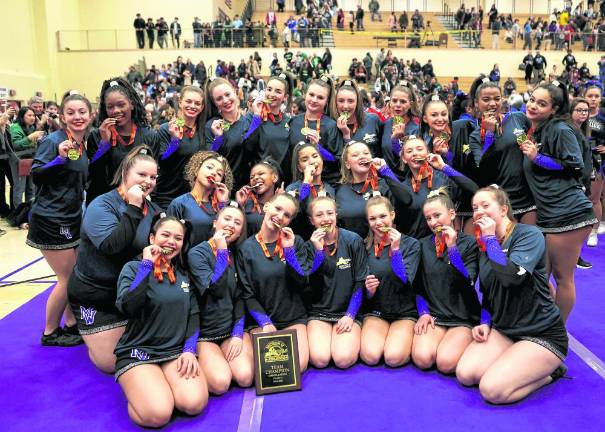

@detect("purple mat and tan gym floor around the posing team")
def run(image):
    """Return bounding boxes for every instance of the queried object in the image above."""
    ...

[0,221,605,432]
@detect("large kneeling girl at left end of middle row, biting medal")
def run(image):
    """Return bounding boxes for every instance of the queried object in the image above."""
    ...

[67,146,159,373]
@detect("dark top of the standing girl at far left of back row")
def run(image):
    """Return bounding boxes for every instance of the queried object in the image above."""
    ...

[31,130,88,224]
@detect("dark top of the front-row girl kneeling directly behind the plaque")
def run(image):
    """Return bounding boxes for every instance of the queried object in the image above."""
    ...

[235,236,310,328]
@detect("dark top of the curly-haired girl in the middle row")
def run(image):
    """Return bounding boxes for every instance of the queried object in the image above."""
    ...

[166,192,216,246]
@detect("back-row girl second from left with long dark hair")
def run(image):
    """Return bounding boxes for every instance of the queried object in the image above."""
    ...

[86,78,160,203]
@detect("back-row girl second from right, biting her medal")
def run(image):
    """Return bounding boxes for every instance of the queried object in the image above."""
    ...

[469,79,536,225]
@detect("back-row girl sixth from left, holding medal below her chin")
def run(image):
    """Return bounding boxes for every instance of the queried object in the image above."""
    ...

[289,75,342,186]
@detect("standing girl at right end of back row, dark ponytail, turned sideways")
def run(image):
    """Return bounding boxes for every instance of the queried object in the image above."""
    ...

[521,81,598,321]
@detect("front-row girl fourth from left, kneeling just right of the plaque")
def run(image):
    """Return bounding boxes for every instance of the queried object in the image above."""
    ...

[307,197,368,368]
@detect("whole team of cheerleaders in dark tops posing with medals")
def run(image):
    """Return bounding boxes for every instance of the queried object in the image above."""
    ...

[27,71,601,426]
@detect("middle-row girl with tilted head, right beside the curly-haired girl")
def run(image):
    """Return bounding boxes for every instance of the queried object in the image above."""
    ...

[235,159,284,233]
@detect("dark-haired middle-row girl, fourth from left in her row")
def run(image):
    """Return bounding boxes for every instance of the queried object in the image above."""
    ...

[286,141,336,239]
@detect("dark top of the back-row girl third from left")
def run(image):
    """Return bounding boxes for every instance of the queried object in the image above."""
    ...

[151,123,205,209]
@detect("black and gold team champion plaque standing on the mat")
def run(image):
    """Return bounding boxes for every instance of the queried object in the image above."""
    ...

[252,330,301,395]
